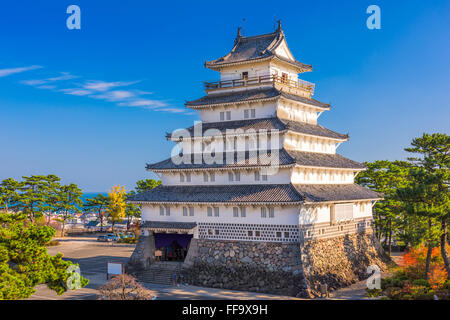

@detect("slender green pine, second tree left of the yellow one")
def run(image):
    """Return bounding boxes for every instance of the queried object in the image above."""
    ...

[56,183,83,237]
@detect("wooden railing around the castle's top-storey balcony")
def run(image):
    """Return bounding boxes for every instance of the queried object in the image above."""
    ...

[204,75,315,95]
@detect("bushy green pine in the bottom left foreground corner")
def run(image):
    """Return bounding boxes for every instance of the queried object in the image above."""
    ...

[0,211,89,300]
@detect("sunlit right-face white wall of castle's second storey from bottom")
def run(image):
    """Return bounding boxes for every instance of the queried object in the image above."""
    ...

[291,166,355,184]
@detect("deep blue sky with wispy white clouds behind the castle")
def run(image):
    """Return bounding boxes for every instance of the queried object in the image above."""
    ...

[0,0,450,192]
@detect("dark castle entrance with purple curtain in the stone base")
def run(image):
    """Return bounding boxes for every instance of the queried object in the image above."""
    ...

[155,233,192,262]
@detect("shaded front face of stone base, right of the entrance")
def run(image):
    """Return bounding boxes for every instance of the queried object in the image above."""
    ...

[183,239,306,296]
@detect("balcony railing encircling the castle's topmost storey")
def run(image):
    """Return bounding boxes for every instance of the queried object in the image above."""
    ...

[204,75,315,97]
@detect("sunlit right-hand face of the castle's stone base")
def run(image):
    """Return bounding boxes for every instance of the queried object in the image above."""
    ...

[301,233,390,295]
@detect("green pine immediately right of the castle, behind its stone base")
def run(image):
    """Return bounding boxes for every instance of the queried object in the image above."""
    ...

[355,160,410,255]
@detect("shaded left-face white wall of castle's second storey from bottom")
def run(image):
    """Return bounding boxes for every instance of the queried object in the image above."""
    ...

[161,168,291,186]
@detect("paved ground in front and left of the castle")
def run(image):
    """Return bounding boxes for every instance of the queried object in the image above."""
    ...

[30,235,386,300]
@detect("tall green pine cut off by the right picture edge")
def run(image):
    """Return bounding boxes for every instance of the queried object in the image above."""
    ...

[405,133,450,279]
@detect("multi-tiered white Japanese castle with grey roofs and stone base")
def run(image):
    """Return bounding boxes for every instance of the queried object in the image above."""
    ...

[130,22,383,296]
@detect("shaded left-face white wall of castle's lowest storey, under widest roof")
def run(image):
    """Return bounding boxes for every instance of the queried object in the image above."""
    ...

[141,204,298,225]
